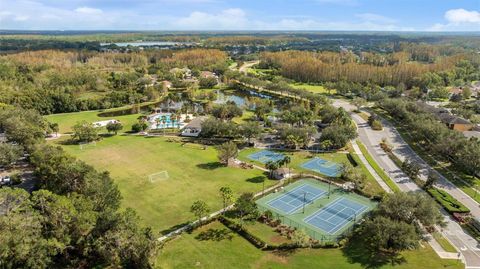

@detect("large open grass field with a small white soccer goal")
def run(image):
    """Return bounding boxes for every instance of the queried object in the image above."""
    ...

[53,135,275,231]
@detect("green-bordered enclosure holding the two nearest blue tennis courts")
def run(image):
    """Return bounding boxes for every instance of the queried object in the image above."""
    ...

[257,179,376,242]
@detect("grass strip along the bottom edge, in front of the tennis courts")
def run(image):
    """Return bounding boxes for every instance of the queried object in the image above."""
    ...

[156,219,464,269]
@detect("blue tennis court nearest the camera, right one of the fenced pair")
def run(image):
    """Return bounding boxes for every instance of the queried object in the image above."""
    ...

[304,198,368,234]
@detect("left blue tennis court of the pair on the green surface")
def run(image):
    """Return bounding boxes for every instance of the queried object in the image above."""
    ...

[267,184,327,214]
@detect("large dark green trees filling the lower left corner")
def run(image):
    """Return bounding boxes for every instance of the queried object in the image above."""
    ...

[0,106,156,268]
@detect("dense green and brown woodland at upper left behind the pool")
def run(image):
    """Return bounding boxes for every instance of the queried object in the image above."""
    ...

[0,49,228,114]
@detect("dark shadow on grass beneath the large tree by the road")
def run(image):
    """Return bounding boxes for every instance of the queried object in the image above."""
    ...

[342,235,406,269]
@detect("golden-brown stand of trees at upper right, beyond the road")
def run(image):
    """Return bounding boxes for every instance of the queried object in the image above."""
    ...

[260,45,480,88]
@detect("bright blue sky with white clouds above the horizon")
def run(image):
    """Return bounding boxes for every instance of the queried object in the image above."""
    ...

[0,0,480,31]
